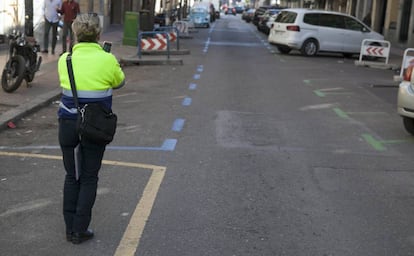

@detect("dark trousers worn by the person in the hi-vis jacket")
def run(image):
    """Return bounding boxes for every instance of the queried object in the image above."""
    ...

[59,119,105,233]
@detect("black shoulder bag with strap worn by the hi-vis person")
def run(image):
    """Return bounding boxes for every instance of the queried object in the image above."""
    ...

[66,54,118,145]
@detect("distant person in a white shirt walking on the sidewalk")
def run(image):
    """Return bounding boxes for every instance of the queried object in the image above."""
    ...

[42,0,62,54]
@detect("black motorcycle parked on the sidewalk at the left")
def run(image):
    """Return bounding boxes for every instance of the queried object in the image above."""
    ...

[1,30,42,93]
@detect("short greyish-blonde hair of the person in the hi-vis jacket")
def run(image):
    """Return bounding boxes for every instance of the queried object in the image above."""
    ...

[72,13,101,42]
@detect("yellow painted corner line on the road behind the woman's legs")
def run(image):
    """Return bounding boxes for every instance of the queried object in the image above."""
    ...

[0,151,167,256]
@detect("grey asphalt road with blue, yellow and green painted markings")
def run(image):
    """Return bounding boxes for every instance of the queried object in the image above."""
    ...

[0,15,414,256]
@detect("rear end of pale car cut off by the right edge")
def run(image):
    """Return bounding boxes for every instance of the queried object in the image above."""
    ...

[397,65,414,135]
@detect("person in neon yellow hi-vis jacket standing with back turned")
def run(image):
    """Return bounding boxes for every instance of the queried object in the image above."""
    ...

[58,13,125,244]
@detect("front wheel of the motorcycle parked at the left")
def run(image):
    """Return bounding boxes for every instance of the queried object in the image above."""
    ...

[1,55,26,93]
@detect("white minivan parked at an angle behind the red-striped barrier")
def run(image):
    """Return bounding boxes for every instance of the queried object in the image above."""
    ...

[268,9,384,57]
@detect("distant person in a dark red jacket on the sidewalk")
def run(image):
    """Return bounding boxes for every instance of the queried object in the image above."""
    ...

[59,0,80,55]
